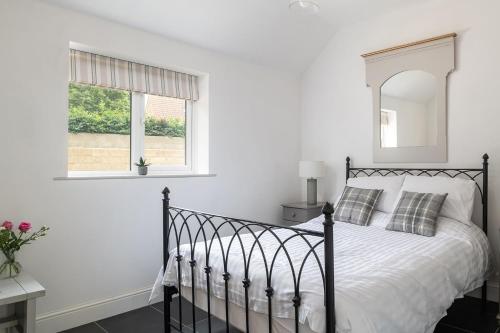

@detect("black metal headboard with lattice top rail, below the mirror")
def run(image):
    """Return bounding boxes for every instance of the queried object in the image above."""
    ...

[346,154,489,305]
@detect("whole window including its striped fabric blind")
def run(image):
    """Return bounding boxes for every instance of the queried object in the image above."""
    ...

[68,50,201,176]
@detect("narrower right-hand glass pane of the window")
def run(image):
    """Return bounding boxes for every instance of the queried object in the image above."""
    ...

[144,95,186,166]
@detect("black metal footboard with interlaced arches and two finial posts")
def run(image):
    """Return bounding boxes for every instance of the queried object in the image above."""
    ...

[163,188,335,333]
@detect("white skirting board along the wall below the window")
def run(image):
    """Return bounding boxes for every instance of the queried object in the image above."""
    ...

[36,287,156,333]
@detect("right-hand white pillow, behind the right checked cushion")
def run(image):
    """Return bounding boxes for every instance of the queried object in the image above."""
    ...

[398,176,476,225]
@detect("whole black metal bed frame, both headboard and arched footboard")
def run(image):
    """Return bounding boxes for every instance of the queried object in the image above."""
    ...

[162,154,488,333]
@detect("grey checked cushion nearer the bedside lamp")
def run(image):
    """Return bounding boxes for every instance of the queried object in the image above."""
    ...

[333,186,383,225]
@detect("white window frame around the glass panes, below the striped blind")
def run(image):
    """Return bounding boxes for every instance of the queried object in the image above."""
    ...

[66,87,196,177]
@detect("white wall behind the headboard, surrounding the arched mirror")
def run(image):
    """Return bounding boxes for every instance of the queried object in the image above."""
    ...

[301,0,500,296]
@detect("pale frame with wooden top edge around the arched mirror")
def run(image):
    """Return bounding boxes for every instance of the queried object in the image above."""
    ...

[362,33,456,163]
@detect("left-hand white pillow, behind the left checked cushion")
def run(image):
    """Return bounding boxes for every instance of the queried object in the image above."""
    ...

[347,176,405,213]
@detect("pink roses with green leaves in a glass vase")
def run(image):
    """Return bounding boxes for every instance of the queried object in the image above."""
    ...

[0,221,49,278]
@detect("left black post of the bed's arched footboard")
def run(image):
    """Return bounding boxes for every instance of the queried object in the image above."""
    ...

[162,187,177,333]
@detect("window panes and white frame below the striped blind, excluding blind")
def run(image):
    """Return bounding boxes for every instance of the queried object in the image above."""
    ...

[68,83,191,172]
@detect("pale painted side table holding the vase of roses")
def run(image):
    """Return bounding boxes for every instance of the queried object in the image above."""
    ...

[0,273,45,333]
